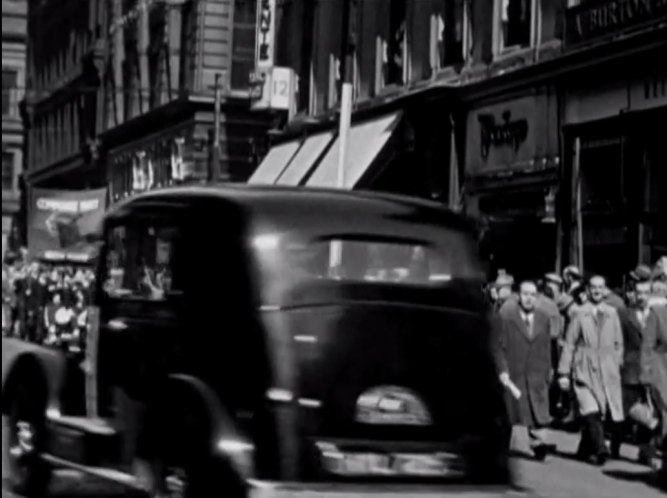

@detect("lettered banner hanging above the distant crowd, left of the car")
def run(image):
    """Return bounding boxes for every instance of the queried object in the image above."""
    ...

[28,189,107,262]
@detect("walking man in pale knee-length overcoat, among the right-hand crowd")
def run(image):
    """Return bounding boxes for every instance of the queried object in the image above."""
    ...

[558,276,624,465]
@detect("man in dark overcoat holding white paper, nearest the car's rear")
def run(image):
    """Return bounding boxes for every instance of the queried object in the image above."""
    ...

[496,281,551,461]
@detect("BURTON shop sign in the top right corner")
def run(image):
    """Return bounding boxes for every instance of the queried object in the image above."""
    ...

[565,0,667,45]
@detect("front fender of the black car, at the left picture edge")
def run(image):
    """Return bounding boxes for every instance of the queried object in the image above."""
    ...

[2,338,66,415]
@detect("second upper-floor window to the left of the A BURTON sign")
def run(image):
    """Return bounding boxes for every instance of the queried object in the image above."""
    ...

[432,0,466,68]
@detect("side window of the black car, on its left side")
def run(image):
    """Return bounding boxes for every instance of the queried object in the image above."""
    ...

[103,223,180,301]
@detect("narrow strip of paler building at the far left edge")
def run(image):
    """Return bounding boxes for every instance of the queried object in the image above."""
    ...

[2,0,27,257]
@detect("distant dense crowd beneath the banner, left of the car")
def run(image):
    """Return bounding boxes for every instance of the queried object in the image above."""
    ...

[2,247,95,352]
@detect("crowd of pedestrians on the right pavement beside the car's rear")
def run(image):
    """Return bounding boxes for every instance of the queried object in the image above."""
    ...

[488,257,667,486]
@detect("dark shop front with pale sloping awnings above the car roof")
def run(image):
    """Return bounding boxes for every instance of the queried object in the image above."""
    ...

[248,94,453,202]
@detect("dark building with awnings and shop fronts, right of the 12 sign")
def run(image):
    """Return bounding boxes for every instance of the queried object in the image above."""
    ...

[250,0,667,282]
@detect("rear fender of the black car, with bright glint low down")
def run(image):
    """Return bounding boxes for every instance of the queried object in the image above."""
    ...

[148,374,254,478]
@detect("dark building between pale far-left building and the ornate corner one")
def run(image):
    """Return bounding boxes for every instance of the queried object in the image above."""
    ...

[24,0,106,191]
